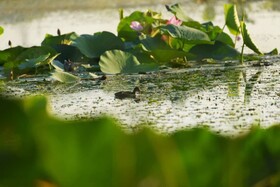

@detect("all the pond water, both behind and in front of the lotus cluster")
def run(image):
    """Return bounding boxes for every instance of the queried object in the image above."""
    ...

[0,0,280,135]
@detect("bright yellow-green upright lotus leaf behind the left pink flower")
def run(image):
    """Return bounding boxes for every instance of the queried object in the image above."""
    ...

[117,11,155,41]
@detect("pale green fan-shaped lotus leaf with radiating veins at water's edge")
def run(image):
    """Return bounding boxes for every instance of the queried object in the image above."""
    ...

[99,50,140,74]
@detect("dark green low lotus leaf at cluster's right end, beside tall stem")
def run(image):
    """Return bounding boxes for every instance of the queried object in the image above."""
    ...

[189,41,239,60]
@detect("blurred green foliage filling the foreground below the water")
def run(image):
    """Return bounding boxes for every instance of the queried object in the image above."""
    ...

[0,97,280,187]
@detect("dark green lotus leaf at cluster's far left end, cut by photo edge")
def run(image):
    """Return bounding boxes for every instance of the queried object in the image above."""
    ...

[0,46,27,65]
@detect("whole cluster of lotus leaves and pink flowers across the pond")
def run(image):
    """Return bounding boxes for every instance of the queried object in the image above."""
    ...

[0,4,277,82]
